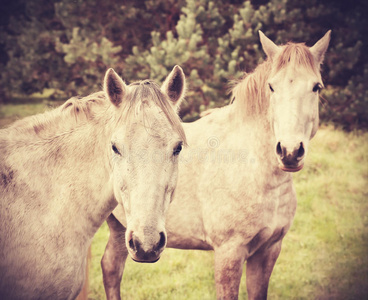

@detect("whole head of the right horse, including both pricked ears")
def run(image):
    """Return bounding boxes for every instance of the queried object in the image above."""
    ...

[261,32,330,172]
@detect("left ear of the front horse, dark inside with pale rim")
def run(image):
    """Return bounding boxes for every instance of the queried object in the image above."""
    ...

[104,68,126,106]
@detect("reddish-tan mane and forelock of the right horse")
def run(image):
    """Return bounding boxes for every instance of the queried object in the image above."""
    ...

[231,43,320,117]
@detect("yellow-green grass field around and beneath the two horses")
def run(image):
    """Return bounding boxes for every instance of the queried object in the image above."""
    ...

[0,104,368,300]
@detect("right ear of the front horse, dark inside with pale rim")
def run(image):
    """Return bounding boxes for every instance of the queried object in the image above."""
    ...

[161,65,185,108]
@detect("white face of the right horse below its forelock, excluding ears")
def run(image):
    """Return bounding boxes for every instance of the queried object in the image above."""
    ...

[269,69,322,172]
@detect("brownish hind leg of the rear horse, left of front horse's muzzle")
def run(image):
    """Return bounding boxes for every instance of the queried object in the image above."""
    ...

[101,214,128,300]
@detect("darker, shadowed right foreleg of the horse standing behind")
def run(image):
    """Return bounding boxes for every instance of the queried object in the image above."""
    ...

[246,240,282,300]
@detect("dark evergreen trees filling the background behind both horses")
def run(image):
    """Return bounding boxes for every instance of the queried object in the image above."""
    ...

[0,0,368,129]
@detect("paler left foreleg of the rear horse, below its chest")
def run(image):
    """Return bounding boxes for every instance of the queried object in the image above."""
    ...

[215,245,245,300]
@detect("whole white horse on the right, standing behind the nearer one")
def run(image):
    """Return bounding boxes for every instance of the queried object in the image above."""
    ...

[102,31,330,299]
